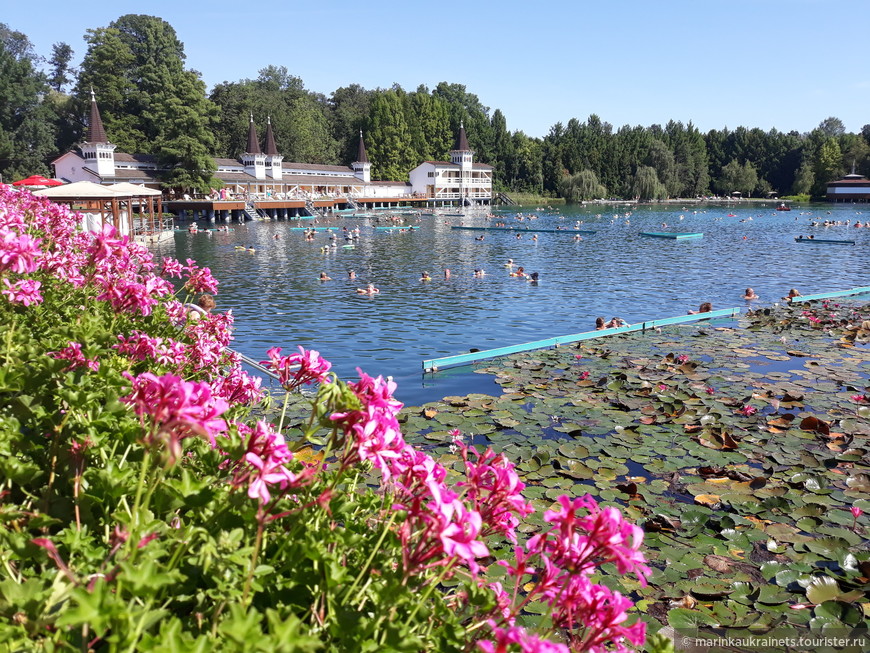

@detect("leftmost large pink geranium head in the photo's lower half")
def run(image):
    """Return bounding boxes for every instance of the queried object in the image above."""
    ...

[121,372,229,464]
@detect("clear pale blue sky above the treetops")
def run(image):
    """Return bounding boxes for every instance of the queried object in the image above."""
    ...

[8,0,870,136]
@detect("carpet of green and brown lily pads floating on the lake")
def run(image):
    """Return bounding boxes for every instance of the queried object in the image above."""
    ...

[396,302,870,630]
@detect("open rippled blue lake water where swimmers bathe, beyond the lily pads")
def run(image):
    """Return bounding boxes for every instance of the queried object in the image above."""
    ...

[156,202,870,405]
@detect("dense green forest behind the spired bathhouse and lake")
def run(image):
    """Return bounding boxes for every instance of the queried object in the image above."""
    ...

[0,14,870,196]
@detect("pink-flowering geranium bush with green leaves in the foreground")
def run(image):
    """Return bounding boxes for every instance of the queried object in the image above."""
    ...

[0,187,649,652]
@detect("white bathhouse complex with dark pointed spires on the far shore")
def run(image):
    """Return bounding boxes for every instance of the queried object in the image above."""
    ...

[52,91,492,208]
